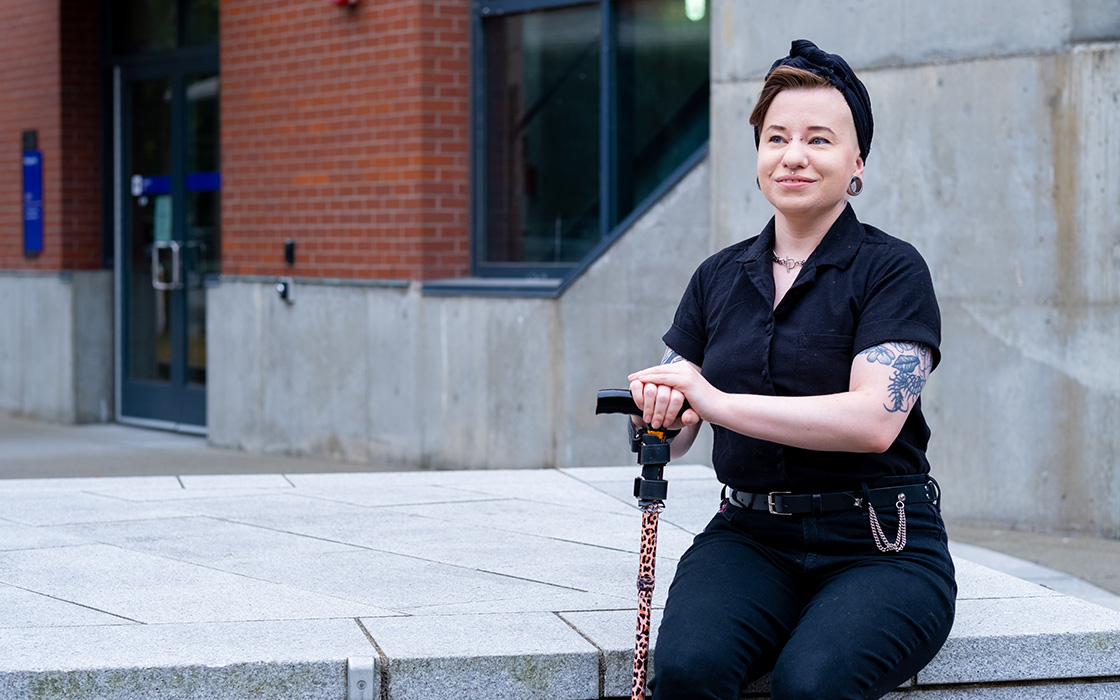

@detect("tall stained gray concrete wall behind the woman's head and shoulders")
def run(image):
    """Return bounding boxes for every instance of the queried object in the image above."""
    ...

[711,0,1120,536]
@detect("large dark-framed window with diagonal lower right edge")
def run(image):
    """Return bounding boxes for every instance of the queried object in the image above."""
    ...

[474,0,709,277]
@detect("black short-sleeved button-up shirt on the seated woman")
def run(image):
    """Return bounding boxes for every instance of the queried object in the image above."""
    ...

[663,205,941,493]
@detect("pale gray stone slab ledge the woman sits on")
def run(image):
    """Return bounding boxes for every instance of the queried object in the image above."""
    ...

[0,465,1120,700]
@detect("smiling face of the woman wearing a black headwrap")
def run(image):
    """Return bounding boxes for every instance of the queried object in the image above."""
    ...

[758,87,864,222]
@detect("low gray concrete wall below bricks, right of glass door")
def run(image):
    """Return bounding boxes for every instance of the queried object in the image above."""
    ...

[207,275,586,468]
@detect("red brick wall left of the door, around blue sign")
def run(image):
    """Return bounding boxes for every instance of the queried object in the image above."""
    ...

[0,0,103,272]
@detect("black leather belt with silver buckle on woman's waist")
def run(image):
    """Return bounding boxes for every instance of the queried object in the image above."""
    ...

[727,480,941,515]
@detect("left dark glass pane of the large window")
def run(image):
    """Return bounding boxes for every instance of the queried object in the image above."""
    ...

[485,7,599,263]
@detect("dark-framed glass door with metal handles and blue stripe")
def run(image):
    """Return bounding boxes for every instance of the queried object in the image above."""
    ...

[118,66,221,431]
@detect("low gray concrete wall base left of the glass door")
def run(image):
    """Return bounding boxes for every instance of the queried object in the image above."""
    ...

[0,271,113,423]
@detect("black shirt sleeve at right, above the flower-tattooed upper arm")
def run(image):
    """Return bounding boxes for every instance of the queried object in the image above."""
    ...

[851,241,941,367]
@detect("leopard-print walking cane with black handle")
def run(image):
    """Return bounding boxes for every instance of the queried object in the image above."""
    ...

[595,389,669,700]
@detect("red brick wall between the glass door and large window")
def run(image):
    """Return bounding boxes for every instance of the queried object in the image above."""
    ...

[221,0,469,279]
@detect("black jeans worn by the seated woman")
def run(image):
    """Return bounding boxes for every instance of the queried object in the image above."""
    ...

[651,478,956,700]
